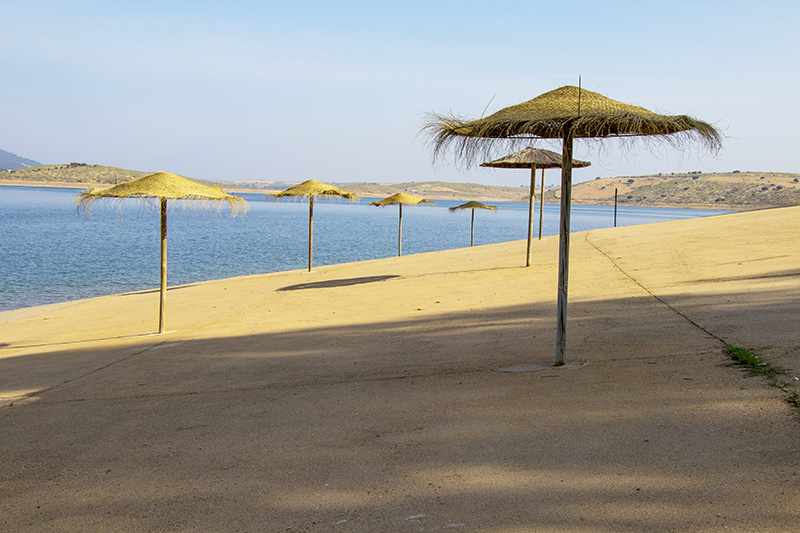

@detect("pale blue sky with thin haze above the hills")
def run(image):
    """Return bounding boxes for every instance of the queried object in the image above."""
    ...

[0,0,800,185]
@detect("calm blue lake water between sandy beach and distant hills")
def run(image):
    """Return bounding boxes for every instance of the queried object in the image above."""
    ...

[0,186,724,311]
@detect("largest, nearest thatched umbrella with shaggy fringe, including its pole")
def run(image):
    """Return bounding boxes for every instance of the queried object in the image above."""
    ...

[425,86,722,366]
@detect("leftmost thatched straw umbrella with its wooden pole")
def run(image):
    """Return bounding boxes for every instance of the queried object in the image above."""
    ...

[77,172,247,333]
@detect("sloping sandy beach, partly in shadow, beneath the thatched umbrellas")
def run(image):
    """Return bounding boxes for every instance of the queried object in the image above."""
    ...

[0,207,800,533]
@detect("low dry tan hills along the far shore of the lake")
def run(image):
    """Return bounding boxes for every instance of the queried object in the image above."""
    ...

[6,163,800,210]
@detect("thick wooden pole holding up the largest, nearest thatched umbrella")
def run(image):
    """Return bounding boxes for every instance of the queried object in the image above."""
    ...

[555,130,572,366]
